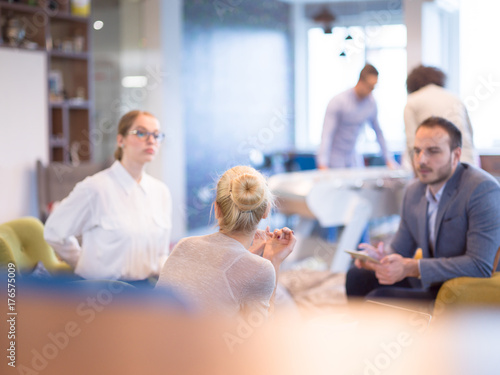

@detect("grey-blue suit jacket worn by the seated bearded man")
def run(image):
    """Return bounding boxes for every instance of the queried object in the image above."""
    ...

[391,163,500,287]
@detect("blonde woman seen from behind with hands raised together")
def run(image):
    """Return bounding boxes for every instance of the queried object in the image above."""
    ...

[157,166,296,315]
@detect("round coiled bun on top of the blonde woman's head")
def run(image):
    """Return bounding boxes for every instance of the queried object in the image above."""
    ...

[231,173,266,211]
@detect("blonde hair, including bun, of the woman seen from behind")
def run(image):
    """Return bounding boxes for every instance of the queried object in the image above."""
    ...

[215,166,273,233]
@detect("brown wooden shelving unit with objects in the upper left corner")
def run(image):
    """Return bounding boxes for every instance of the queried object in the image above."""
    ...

[0,0,94,163]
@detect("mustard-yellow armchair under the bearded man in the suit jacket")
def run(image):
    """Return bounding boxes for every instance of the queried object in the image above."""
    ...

[433,247,500,315]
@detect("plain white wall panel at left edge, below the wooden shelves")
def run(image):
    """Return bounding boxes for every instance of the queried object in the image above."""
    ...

[0,49,49,222]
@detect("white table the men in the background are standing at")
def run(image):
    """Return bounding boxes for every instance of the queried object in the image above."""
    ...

[269,167,412,272]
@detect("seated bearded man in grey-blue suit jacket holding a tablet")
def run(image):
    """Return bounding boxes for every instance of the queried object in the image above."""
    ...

[346,117,500,300]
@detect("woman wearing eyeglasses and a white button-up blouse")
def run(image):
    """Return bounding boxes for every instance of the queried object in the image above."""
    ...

[45,111,172,286]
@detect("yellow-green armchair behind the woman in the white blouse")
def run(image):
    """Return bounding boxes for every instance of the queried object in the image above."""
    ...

[0,217,73,275]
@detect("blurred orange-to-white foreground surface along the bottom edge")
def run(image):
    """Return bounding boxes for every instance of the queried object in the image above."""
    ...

[0,275,500,375]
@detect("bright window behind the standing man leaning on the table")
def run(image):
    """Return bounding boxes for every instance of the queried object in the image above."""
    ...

[308,25,407,153]
